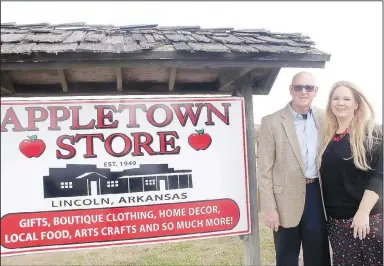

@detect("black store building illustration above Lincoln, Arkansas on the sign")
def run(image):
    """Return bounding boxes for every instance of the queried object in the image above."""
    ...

[43,164,193,198]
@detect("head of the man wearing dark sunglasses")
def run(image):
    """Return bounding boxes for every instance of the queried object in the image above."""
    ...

[290,74,317,108]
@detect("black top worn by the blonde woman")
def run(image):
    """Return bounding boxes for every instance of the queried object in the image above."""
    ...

[320,131,383,219]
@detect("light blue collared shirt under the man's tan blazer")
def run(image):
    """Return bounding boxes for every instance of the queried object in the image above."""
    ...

[288,103,318,178]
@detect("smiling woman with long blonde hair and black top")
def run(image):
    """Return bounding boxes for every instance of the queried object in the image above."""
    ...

[318,81,383,266]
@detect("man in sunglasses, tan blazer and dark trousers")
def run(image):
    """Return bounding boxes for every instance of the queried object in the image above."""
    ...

[258,72,331,266]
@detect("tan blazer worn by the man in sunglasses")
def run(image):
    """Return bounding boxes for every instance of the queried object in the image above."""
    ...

[258,105,323,228]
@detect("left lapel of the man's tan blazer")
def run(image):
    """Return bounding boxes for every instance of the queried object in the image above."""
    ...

[281,106,305,173]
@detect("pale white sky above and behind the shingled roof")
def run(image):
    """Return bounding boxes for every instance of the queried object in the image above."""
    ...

[1,1,383,123]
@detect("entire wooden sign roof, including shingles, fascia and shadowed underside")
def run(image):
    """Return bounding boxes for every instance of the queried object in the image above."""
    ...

[0,23,331,95]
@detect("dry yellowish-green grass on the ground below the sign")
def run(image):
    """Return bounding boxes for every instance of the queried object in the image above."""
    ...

[1,217,275,265]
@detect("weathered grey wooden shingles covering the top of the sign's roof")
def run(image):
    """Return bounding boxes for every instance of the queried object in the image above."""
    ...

[1,23,329,57]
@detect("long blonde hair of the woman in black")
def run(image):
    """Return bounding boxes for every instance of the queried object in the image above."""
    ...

[318,81,381,171]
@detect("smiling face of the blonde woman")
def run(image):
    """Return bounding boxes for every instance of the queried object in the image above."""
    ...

[331,86,358,119]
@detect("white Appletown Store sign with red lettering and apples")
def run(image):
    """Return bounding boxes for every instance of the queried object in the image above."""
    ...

[1,96,250,256]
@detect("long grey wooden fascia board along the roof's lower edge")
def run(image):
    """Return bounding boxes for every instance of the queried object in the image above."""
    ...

[1,52,330,70]
